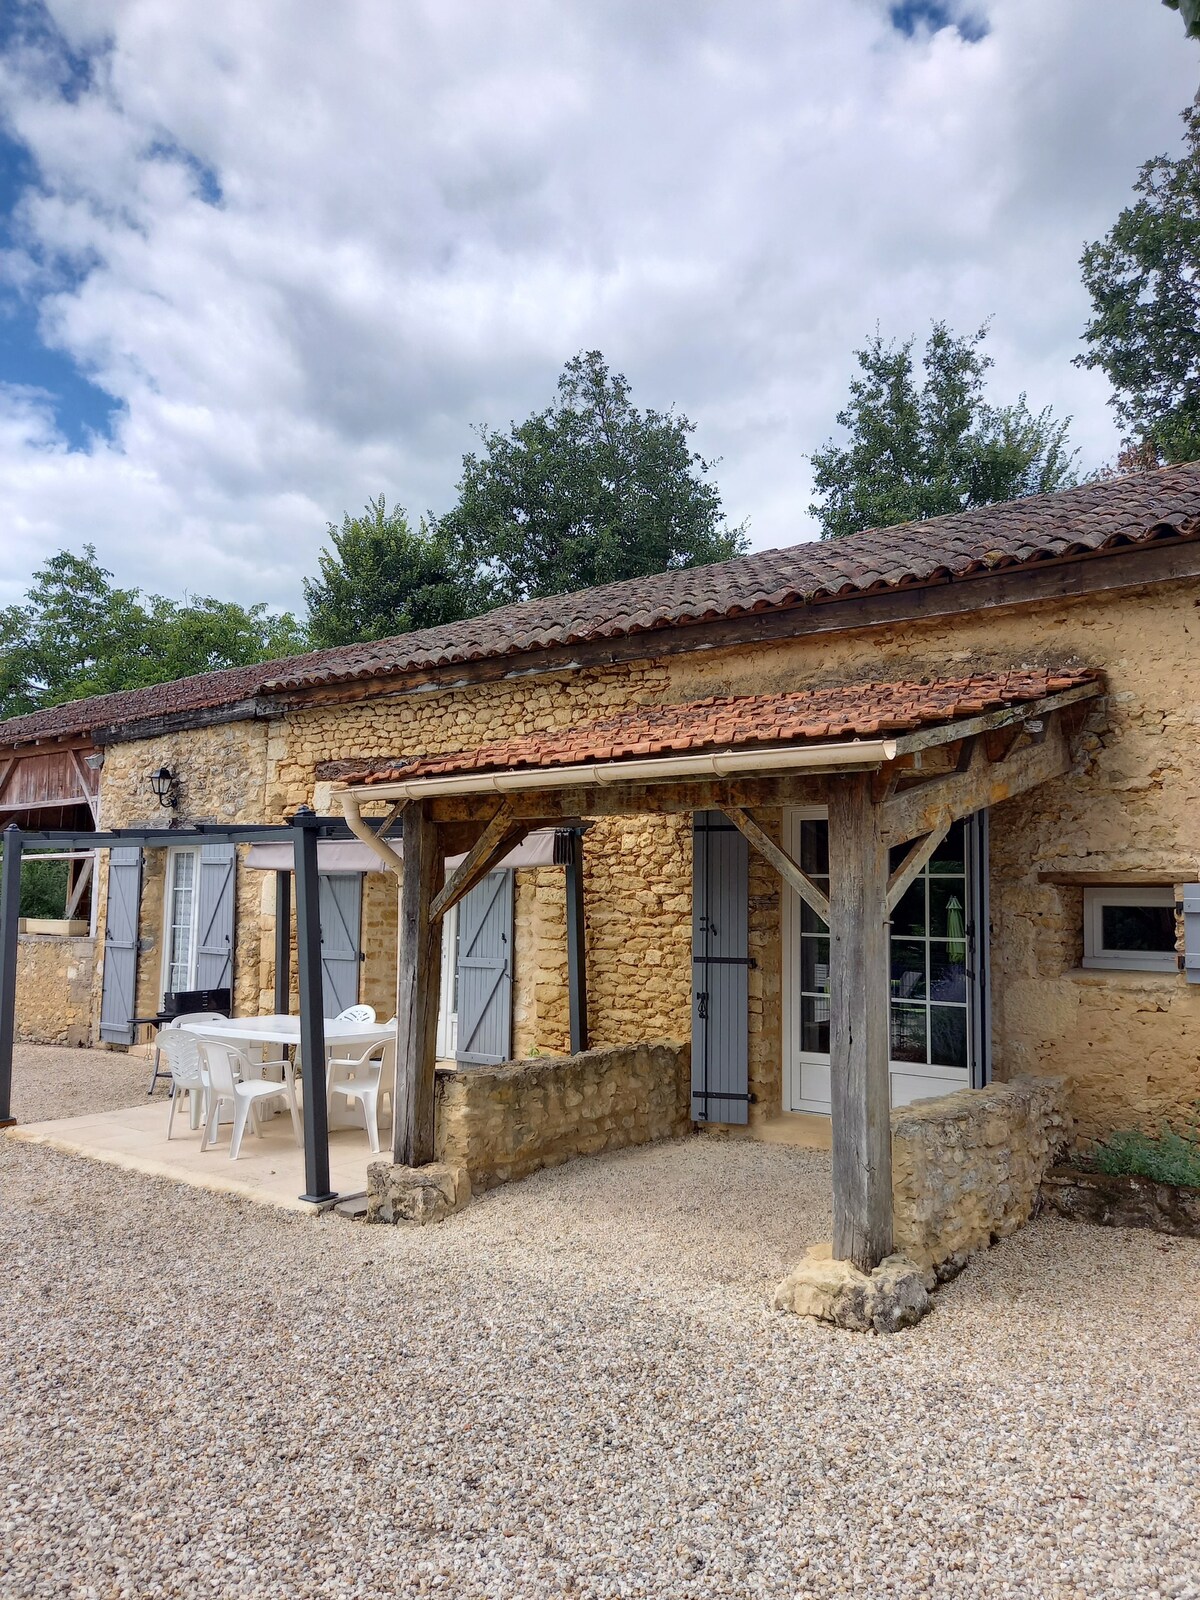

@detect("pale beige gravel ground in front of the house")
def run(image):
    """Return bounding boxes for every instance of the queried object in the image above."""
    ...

[0,1050,1200,1600]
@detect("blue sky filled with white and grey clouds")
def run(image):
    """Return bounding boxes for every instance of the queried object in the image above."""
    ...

[0,0,1200,608]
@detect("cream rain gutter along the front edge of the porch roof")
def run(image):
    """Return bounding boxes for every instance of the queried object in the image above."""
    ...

[336,739,896,806]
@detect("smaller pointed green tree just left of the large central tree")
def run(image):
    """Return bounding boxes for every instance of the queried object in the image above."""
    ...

[304,494,482,648]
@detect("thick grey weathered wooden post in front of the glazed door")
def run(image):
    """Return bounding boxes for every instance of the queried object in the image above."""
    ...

[829,774,891,1272]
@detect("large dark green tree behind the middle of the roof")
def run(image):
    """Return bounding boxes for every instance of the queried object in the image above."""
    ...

[435,350,746,605]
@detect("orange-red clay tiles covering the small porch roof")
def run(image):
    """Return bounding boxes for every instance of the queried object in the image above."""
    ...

[344,670,1096,784]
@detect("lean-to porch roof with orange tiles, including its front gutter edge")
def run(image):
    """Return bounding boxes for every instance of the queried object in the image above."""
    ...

[336,669,1099,797]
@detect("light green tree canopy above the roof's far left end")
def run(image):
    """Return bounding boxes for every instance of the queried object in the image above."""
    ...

[0,544,306,717]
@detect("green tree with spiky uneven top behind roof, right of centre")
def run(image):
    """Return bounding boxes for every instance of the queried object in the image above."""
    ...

[810,322,1077,539]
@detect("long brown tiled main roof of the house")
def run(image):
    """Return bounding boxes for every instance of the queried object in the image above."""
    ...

[0,464,1200,744]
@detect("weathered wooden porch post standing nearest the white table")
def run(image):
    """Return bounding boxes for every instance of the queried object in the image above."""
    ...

[392,802,442,1166]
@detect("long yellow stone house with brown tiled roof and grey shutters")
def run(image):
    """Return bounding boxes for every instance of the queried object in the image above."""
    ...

[0,466,1200,1235]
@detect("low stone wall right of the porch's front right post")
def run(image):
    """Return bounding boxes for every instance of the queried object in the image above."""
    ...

[891,1078,1070,1267]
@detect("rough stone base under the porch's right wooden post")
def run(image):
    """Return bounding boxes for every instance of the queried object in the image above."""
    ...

[774,1245,936,1333]
